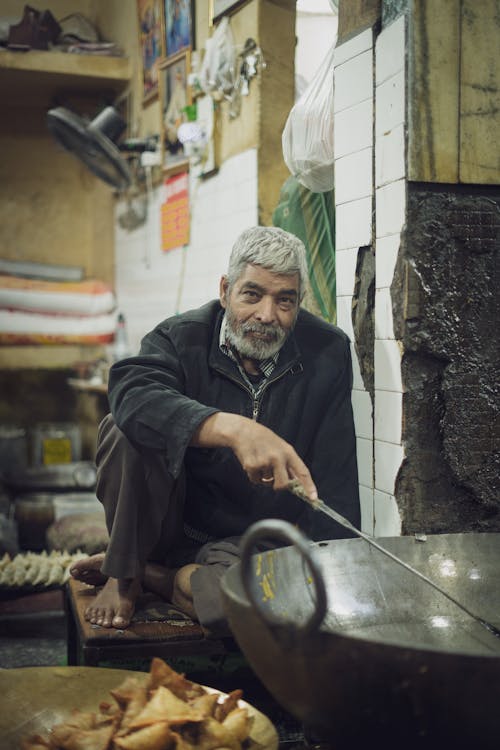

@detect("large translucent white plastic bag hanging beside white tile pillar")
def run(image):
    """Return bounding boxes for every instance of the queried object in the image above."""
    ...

[282,45,335,193]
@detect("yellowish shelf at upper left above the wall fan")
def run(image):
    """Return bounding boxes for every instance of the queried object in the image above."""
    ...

[0,48,132,107]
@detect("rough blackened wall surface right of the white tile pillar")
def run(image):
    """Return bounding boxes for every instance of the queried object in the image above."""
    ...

[391,183,500,533]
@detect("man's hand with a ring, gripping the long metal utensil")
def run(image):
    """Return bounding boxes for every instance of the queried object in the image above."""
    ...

[191,412,318,500]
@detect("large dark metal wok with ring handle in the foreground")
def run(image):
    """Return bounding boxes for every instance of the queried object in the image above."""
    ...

[222,521,500,750]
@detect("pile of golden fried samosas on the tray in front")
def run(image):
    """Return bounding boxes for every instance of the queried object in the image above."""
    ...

[21,658,253,750]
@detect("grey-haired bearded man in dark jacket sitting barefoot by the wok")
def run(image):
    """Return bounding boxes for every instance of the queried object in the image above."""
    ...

[72,227,360,632]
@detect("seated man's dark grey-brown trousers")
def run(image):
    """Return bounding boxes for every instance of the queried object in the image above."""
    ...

[96,414,240,637]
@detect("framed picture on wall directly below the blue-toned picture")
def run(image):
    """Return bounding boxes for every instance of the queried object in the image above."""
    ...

[159,50,192,167]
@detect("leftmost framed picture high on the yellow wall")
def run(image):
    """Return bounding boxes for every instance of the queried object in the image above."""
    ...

[137,0,165,104]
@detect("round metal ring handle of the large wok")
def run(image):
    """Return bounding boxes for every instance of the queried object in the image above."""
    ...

[241,518,328,635]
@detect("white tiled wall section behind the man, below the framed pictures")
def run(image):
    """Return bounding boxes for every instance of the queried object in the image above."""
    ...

[116,149,258,350]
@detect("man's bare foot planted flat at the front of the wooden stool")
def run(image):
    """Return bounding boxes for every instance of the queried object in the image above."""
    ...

[84,578,142,629]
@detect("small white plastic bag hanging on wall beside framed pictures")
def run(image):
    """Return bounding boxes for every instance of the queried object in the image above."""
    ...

[200,16,236,97]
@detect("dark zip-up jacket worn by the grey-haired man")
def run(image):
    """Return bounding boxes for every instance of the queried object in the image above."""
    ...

[109,301,360,540]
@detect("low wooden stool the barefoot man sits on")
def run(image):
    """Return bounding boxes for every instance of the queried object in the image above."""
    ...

[65,579,235,667]
